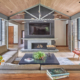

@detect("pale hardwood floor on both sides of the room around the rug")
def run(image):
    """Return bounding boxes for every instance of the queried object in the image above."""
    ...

[9,45,80,65]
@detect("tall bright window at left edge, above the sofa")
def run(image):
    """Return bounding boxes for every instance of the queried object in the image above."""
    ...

[0,19,5,46]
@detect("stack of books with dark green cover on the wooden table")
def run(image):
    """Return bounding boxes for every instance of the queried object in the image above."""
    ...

[47,68,69,80]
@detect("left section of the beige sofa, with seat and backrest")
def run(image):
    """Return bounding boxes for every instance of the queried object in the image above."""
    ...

[0,45,18,64]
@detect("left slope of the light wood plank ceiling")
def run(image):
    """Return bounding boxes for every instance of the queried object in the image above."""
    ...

[0,0,39,16]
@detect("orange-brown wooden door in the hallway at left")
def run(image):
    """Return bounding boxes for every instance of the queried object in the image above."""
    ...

[8,26,14,44]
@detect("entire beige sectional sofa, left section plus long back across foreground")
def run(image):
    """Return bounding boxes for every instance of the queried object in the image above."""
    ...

[0,45,80,74]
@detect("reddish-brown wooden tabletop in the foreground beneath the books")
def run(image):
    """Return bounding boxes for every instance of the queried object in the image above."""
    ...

[0,72,80,80]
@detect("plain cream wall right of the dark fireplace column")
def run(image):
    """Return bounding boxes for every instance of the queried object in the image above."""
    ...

[54,20,66,46]
